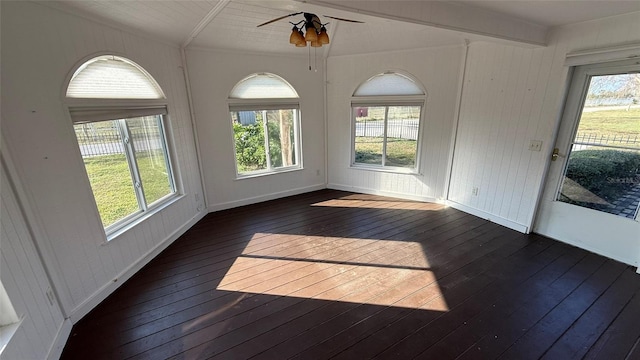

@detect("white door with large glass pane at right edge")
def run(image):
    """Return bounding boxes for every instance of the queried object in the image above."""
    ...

[534,61,640,265]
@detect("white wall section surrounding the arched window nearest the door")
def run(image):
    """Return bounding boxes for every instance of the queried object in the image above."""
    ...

[327,46,464,201]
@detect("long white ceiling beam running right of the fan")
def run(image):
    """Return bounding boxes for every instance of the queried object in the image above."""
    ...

[296,0,549,46]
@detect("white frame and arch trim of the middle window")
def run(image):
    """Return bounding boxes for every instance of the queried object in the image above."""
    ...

[228,73,303,180]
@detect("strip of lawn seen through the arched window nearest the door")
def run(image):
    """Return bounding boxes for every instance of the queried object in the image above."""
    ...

[355,136,417,168]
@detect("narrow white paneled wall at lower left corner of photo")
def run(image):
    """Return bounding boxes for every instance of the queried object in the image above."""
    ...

[0,162,64,359]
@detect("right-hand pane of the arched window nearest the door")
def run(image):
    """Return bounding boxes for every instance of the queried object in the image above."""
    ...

[385,106,420,168]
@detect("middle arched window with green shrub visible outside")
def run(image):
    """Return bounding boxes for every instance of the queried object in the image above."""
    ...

[229,73,301,177]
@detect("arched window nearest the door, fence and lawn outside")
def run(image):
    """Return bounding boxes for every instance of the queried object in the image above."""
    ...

[351,72,426,172]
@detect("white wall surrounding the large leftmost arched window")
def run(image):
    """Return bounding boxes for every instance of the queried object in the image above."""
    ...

[1,1,202,328]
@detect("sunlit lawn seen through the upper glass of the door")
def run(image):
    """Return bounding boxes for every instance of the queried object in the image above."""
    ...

[578,108,640,135]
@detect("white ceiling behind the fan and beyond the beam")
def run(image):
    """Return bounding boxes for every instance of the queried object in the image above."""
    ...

[41,0,640,56]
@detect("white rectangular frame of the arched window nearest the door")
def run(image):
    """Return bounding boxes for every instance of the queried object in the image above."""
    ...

[350,95,426,174]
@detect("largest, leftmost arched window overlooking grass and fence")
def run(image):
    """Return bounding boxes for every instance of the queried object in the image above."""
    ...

[66,55,176,238]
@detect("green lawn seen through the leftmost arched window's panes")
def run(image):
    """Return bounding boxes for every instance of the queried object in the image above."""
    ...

[84,153,171,227]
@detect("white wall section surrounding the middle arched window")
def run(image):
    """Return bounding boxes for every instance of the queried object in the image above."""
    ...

[187,49,325,211]
